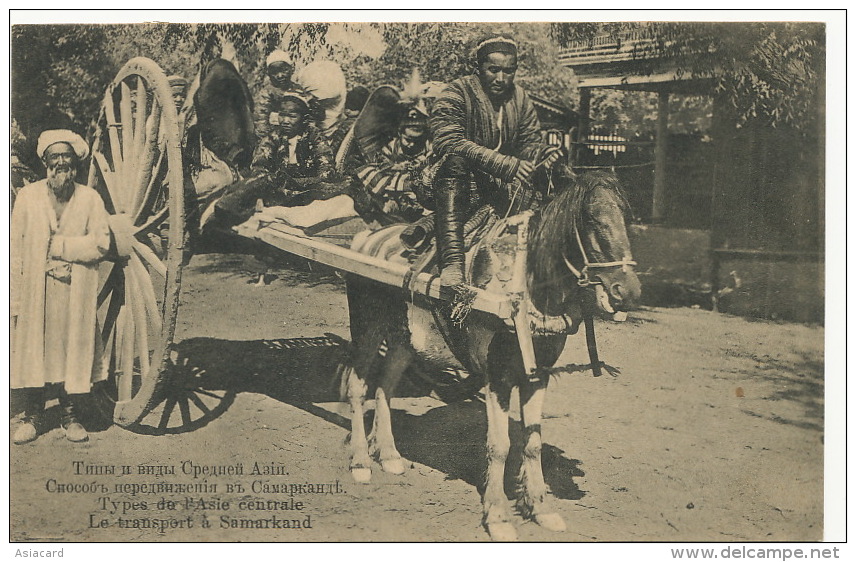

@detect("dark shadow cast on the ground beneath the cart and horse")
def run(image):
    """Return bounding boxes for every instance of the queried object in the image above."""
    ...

[123,335,583,500]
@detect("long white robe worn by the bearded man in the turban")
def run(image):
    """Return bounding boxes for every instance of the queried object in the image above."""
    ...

[10,180,110,394]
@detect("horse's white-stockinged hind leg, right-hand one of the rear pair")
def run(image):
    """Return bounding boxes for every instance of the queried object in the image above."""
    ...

[372,344,412,474]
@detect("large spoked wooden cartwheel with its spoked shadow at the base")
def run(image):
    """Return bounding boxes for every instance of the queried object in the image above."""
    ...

[88,57,234,433]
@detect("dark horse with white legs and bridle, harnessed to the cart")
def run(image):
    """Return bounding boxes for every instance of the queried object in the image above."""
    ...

[341,171,641,540]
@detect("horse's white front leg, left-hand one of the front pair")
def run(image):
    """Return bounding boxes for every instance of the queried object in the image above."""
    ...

[482,381,517,541]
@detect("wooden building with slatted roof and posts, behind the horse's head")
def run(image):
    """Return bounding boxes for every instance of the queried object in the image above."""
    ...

[560,24,824,320]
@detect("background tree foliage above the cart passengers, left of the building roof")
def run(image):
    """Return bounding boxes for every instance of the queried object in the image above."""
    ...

[11,23,574,152]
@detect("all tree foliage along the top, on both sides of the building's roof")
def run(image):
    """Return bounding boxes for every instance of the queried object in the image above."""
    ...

[11,22,825,154]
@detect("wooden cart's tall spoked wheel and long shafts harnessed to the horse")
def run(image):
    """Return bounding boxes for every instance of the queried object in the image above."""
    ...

[88,57,598,433]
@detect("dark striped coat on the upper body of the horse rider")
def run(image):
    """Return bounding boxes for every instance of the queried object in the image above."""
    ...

[430,75,542,181]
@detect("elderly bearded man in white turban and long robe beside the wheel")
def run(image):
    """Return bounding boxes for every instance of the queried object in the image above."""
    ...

[10,130,110,444]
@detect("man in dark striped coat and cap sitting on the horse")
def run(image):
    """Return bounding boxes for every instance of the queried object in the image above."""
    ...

[430,36,561,286]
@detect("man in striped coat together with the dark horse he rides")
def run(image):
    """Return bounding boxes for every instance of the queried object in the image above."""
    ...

[342,37,640,540]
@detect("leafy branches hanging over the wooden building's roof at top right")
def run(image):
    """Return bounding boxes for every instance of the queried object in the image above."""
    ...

[551,22,825,129]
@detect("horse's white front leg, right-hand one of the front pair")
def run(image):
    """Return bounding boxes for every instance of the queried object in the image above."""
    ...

[517,375,566,531]
